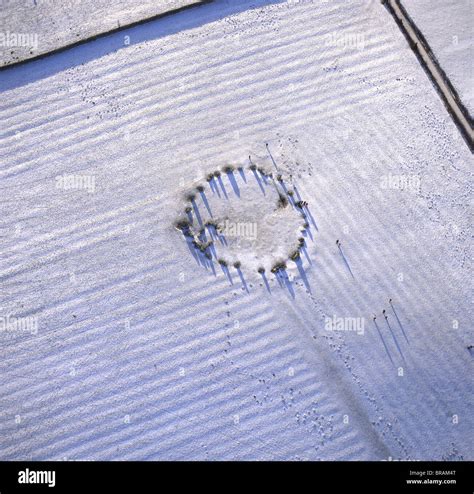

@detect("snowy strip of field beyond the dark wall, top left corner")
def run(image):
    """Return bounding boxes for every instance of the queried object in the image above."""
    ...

[0,0,201,67]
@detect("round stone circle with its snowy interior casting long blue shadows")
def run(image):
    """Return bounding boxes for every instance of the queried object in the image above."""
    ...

[175,157,310,273]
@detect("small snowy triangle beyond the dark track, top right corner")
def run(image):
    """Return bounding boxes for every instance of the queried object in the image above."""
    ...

[402,0,474,116]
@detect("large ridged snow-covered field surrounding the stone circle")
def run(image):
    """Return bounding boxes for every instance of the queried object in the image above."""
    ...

[0,0,474,460]
